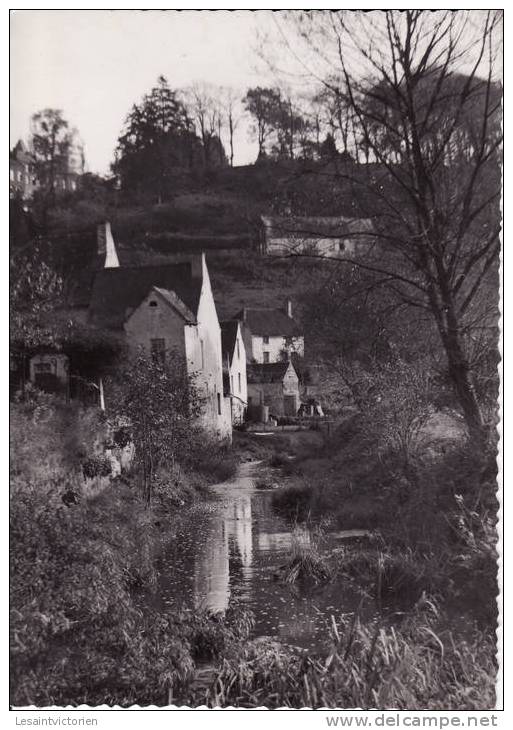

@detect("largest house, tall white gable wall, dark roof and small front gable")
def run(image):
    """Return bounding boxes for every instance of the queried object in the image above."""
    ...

[88,225,231,438]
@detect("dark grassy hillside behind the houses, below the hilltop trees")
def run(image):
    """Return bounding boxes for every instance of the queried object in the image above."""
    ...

[11,160,364,330]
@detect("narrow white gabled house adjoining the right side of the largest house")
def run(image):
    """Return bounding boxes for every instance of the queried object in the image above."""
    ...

[221,320,248,425]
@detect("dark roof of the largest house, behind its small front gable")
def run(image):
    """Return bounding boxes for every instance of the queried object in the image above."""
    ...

[89,263,201,329]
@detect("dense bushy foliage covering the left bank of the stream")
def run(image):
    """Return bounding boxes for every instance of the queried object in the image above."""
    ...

[10,400,251,706]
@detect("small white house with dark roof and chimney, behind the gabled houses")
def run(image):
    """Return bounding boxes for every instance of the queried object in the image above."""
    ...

[236,300,305,363]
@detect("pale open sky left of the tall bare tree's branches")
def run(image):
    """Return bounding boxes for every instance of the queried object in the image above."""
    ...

[10,10,278,174]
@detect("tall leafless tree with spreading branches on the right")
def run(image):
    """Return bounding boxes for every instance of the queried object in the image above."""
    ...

[274,10,502,442]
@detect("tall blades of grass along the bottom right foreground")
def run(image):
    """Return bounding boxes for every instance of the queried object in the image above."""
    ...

[201,600,496,710]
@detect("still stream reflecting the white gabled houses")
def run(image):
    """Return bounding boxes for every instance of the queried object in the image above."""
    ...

[158,462,370,650]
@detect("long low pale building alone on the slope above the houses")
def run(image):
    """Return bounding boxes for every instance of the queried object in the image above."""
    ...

[260,216,376,258]
